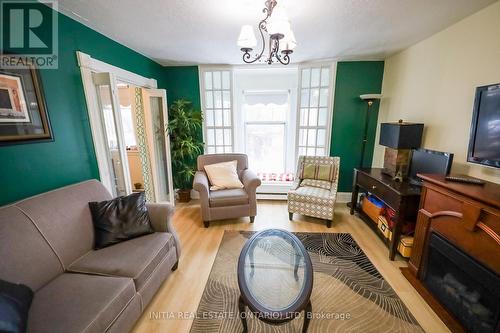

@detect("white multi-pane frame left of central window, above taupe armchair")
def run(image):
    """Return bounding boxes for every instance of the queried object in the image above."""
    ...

[198,66,235,153]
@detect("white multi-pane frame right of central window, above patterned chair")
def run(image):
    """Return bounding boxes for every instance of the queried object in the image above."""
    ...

[295,62,337,159]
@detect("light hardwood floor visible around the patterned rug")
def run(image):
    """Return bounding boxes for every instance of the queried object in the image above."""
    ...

[133,200,449,333]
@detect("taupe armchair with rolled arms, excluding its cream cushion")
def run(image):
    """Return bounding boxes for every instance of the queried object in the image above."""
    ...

[193,154,261,228]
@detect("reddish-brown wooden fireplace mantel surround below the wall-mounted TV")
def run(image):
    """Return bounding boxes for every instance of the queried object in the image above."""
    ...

[402,175,500,332]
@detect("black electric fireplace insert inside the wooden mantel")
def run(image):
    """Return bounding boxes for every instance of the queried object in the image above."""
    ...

[422,232,500,333]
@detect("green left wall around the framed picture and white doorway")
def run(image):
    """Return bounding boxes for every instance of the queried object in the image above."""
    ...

[0,2,165,205]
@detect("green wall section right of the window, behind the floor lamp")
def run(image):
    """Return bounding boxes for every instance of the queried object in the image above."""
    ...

[330,61,384,192]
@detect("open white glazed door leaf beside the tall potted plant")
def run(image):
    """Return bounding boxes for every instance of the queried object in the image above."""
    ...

[141,88,175,204]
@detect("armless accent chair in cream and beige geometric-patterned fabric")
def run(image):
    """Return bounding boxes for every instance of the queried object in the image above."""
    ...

[287,156,340,228]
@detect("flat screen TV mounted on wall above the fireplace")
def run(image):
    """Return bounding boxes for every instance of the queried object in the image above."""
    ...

[467,84,500,168]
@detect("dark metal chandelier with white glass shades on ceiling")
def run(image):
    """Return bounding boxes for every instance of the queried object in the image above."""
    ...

[238,0,297,65]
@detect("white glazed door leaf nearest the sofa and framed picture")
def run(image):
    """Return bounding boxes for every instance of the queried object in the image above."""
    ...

[92,73,132,196]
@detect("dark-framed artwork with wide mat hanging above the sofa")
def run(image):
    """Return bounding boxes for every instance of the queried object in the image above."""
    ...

[0,56,53,145]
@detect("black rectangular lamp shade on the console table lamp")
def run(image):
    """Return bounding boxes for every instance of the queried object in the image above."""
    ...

[379,121,424,149]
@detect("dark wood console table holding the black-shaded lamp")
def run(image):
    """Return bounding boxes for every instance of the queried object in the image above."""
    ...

[351,168,421,260]
